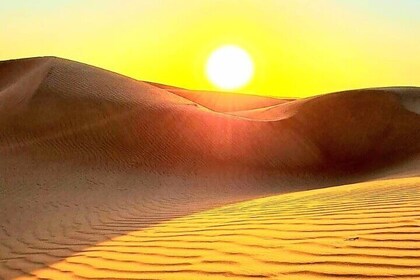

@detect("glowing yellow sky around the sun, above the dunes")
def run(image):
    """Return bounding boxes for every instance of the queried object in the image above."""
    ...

[0,0,420,97]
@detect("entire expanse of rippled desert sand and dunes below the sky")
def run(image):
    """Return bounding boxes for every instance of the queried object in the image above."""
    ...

[0,57,420,279]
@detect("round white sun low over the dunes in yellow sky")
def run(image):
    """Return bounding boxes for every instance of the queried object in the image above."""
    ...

[206,45,254,90]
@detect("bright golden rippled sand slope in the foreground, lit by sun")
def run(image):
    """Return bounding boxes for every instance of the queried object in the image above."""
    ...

[20,177,420,279]
